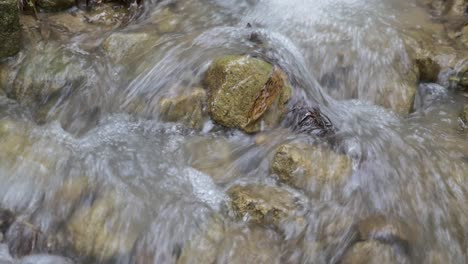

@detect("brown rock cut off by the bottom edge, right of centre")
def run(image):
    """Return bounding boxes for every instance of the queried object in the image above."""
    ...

[340,241,410,264]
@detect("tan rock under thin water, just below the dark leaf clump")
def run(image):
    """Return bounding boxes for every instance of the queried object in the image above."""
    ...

[271,144,352,191]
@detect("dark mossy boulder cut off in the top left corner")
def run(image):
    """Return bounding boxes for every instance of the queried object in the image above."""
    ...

[0,0,21,59]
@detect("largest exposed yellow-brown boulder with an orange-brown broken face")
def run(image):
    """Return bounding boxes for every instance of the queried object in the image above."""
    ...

[204,56,291,133]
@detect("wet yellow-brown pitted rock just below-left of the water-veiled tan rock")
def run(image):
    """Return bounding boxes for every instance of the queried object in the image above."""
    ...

[228,185,299,225]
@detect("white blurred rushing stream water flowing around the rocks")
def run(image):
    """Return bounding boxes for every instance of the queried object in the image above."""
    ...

[0,0,468,264]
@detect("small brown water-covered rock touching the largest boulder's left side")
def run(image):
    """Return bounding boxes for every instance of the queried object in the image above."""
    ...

[159,88,206,128]
